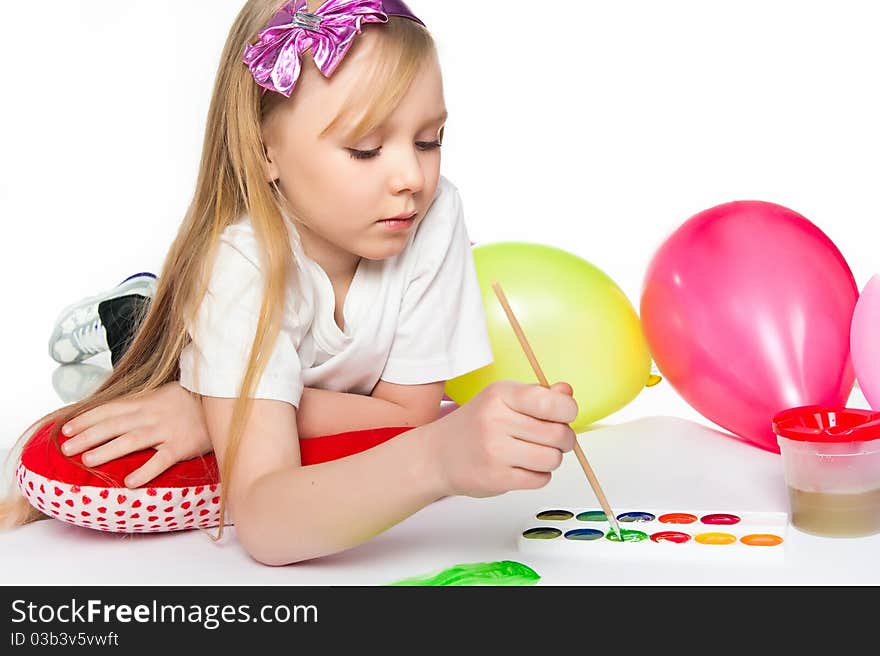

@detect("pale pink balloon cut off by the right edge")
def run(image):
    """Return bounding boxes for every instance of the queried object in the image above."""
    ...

[850,275,880,410]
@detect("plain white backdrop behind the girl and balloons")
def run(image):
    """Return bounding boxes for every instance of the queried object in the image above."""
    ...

[0,0,880,446]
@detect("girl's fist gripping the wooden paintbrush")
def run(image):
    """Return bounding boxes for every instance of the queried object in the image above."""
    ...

[427,381,578,497]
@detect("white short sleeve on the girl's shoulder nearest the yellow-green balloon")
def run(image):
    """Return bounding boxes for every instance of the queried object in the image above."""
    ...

[381,179,493,385]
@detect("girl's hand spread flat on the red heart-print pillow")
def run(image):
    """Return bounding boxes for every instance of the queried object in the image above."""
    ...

[61,383,213,488]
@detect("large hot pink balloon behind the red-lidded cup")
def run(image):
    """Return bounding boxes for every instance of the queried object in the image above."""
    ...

[640,201,858,453]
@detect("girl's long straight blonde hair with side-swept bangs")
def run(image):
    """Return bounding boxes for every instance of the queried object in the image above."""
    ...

[0,0,434,540]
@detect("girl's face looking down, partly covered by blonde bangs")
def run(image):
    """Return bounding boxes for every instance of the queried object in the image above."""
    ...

[263,30,446,274]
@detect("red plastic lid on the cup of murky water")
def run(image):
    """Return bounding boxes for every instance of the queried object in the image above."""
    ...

[773,405,880,443]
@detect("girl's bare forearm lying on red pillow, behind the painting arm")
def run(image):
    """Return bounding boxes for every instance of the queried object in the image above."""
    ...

[296,387,417,438]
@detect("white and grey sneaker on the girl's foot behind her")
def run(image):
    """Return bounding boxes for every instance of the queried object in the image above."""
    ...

[49,273,157,364]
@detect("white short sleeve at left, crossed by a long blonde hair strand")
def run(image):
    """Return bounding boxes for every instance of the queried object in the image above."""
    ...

[180,226,303,406]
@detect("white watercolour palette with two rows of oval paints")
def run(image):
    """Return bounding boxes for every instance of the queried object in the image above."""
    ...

[518,506,788,561]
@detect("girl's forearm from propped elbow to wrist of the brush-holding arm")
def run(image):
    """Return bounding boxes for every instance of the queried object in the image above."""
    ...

[235,425,447,565]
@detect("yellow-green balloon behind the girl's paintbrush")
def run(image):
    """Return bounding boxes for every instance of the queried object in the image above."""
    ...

[446,242,651,432]
